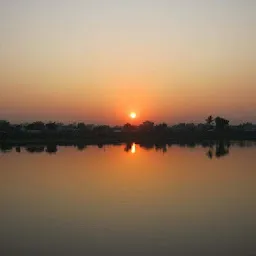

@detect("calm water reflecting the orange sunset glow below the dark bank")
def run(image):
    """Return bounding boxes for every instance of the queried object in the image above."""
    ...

[0,143,256,256]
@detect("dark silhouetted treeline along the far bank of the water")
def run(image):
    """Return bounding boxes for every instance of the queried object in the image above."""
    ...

[0,116,256,142]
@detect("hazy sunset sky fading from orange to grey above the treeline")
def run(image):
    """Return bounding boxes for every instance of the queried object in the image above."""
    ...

[0,0,256,124]
